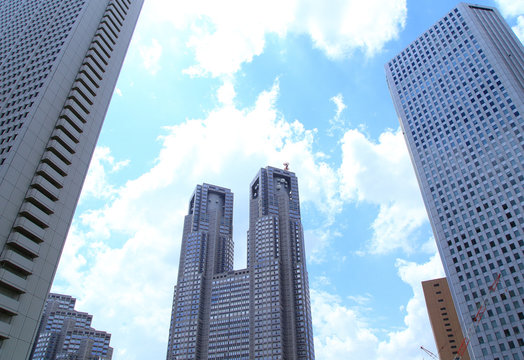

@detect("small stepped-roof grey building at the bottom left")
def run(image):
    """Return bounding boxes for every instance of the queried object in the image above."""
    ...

[30,294,113,360]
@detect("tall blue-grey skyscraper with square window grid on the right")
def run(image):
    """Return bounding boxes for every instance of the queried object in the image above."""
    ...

[385,3,524,360]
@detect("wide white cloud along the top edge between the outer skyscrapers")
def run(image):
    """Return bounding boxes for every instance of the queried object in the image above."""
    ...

[138,0,407,76]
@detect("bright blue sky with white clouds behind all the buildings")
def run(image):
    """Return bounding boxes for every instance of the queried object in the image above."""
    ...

[53,0,524,360]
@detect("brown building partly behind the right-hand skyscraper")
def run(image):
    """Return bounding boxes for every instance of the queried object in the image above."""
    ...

[422,278,470,360]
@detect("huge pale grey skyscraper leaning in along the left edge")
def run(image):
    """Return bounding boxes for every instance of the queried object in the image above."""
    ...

[0,0,143,360]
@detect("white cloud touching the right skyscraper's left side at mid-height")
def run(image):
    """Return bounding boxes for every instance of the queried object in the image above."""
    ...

[339,129,427,253]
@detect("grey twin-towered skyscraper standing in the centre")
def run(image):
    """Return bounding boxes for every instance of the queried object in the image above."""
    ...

[167,167,315,360]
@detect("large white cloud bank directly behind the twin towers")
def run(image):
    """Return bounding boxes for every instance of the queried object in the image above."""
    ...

[54,79,339,359]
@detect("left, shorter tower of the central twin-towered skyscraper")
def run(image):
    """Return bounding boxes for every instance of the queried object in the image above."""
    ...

[167,184,233,360]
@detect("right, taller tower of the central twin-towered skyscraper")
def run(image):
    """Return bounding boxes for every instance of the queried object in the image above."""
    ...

[248,167,315,359]
